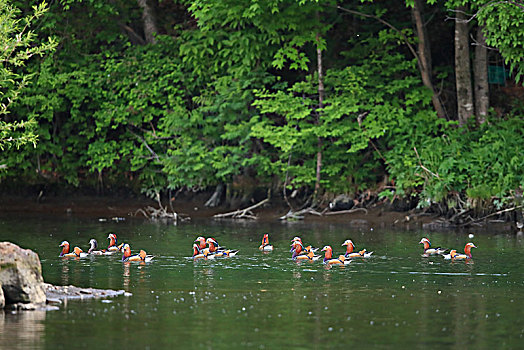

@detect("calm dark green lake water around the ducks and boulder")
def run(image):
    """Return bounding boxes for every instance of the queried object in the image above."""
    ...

[0,216,524,349]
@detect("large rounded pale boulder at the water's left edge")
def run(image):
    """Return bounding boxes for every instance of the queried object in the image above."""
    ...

[0,242,46,308]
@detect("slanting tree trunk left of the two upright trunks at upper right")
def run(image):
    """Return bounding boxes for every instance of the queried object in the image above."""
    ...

[411,0,446,118]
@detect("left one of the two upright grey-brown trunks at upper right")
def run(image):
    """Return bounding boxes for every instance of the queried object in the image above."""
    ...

[455,6,474,126]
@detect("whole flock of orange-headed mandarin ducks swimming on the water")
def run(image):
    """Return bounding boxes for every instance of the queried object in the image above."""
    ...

[59,233,477,266]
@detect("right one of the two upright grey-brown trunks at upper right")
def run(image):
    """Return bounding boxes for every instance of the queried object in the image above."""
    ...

[473,26,489,124]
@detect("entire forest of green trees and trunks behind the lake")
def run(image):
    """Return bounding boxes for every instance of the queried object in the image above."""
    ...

[0,0,524,224]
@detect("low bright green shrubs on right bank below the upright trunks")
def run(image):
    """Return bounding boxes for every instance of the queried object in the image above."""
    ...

[387,118,524,206]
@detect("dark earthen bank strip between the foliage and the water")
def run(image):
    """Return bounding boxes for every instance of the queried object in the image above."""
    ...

[0,194,512,230]
